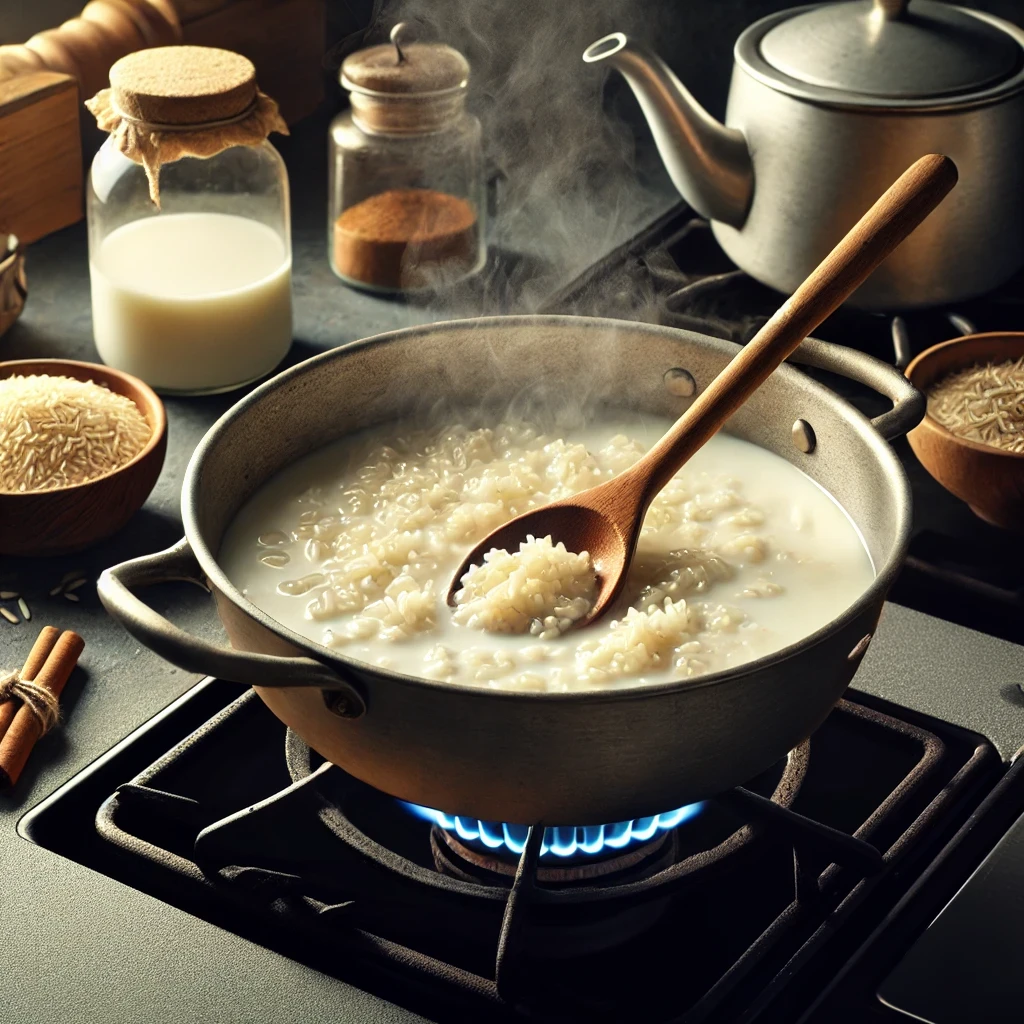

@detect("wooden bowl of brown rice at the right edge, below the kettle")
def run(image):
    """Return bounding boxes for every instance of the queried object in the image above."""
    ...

[906,332,1024,530]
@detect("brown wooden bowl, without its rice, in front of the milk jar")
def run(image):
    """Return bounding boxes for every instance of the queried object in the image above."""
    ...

[0,359,167,555]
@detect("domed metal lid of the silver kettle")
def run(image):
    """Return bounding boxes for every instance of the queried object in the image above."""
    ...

[760,0,1024,99]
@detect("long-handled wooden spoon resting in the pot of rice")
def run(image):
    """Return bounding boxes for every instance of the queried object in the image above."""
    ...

[447,154,956,626]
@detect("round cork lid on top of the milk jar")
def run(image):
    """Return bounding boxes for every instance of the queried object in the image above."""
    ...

[111,46,258,125]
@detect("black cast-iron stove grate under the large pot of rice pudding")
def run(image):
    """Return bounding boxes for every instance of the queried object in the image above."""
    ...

[74,694,990,1024]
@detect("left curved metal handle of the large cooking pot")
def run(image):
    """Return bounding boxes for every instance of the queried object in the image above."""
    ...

[96,538,367,718]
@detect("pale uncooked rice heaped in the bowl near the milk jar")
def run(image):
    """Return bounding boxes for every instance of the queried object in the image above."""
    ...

[0,374,153,494]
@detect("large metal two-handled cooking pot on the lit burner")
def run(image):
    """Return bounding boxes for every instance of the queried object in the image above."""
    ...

[98,316,924,824]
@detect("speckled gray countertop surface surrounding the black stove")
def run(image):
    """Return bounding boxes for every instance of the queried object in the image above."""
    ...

[0,114,1024,1024]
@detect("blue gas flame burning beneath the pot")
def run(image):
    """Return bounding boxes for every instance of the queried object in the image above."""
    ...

[399,801,703,857]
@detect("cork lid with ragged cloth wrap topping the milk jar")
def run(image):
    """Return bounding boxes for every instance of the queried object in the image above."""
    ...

[85,46,288,207]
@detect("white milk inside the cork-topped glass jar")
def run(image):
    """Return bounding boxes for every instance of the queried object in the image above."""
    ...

[90,213,292,393]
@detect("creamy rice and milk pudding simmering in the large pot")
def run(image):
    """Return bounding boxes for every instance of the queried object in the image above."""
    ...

[219,411,874,691]
